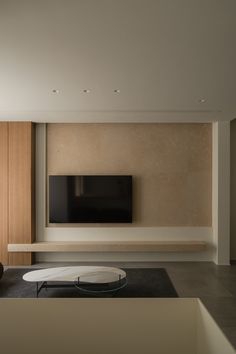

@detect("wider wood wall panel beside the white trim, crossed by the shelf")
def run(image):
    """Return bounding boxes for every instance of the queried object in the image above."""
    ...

[8,122,34,265]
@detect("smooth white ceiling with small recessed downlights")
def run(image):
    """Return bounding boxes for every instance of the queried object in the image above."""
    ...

[0,0,236,122]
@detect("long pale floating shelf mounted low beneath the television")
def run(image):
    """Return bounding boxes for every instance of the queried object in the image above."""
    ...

[8,241,207,252]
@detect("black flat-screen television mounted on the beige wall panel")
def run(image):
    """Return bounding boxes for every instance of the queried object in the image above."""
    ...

[49,175,132,223]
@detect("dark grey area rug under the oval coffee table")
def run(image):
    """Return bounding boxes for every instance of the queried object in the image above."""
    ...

[0,268,178,298]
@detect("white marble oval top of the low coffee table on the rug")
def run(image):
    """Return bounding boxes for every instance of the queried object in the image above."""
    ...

[23,266,126,284]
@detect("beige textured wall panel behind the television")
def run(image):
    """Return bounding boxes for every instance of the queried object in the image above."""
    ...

[47,124,212,226]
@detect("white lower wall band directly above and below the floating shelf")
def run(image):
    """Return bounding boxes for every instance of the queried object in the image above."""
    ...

[37,227,213,262]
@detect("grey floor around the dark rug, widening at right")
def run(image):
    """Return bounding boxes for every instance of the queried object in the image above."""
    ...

[4,262,236,348]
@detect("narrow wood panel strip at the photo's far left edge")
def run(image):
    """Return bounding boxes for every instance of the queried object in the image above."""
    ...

[0,122,8,265]
